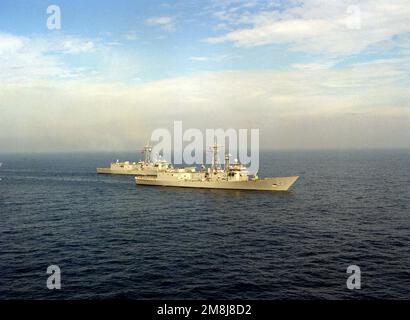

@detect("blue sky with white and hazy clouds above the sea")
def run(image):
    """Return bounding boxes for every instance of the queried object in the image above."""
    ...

[0,0,410,153]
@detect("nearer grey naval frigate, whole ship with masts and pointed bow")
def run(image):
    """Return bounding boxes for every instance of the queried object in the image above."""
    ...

[135,142,299,191]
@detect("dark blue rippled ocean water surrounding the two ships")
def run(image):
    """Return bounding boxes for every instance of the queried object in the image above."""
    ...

[0,151,410,299]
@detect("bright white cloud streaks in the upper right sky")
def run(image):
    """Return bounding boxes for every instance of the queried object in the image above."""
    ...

[205,0,410,56]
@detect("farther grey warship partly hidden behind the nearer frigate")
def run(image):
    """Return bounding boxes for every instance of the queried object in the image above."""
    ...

[97,144,171,176]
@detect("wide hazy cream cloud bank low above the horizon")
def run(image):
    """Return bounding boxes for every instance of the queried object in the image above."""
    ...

[0,59,410,151]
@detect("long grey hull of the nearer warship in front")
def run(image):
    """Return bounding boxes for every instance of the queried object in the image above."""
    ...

[135,176,299,191]
